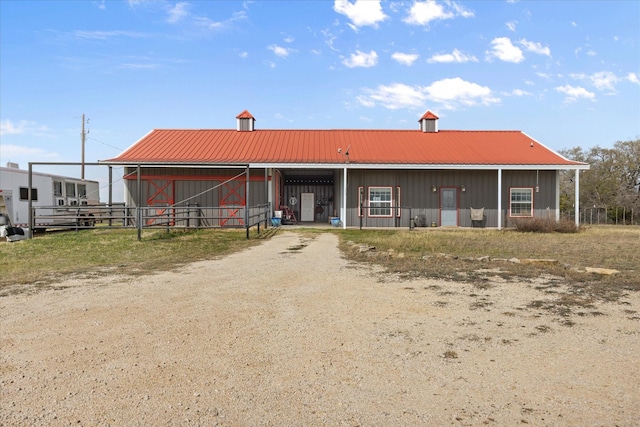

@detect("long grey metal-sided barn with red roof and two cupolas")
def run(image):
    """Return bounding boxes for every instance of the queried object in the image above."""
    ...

[101,110,589,228]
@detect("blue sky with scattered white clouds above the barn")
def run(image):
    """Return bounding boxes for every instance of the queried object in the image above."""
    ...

[0,0,640,194]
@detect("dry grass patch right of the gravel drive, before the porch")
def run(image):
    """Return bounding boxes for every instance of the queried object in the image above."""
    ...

[340,226,640,310]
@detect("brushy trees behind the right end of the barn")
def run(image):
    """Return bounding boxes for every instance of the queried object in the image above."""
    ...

[560,138,640,224]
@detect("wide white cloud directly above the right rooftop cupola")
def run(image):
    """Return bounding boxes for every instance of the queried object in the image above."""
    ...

[358,77,500,110]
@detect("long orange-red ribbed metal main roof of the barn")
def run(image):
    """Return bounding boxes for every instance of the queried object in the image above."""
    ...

[105,127,583,166]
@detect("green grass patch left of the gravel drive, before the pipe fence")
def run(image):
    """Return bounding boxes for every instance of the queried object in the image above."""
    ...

[0,230,260,290]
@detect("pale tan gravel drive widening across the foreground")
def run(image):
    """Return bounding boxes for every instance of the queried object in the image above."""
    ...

[0,232,640,426]
